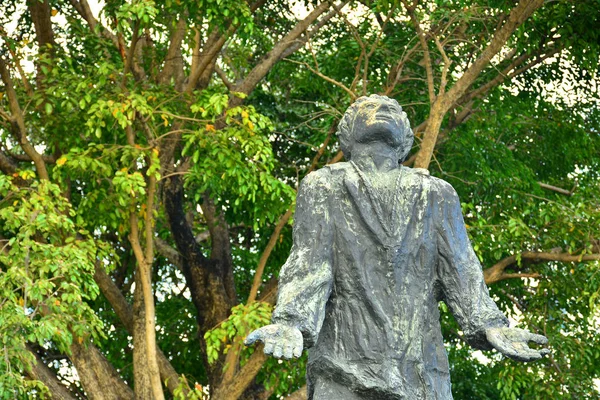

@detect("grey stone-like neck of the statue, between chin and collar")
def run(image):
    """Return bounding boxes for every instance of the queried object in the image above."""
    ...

[352,142,398,173]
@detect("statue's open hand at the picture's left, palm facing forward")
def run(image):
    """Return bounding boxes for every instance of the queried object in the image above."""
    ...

[244,324,304,359]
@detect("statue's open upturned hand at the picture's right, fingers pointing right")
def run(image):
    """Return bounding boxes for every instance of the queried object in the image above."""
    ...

[485,328,550,361]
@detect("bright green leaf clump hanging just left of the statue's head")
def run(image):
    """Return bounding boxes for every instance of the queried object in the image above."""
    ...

[183,91,295,230]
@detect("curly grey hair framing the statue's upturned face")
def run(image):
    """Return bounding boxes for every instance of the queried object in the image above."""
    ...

[337,94,414,162]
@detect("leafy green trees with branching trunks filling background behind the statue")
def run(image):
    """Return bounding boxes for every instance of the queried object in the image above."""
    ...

[0,0,600,399]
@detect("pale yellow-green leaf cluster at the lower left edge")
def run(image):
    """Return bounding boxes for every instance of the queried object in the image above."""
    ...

[0,179,106,398]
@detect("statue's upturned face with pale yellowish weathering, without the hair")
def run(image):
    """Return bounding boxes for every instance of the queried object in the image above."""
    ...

[352,98,404,148]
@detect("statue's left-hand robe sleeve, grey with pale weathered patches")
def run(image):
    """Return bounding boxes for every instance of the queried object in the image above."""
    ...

[272,169,333,347]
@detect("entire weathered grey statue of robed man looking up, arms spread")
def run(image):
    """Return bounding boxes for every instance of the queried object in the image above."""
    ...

[246,95,548,400]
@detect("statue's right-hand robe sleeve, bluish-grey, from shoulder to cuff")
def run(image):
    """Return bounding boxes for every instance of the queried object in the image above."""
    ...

[437,181,508,350]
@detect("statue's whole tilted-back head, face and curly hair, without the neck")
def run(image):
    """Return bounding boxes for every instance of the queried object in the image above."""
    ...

[337,94,414,161]
